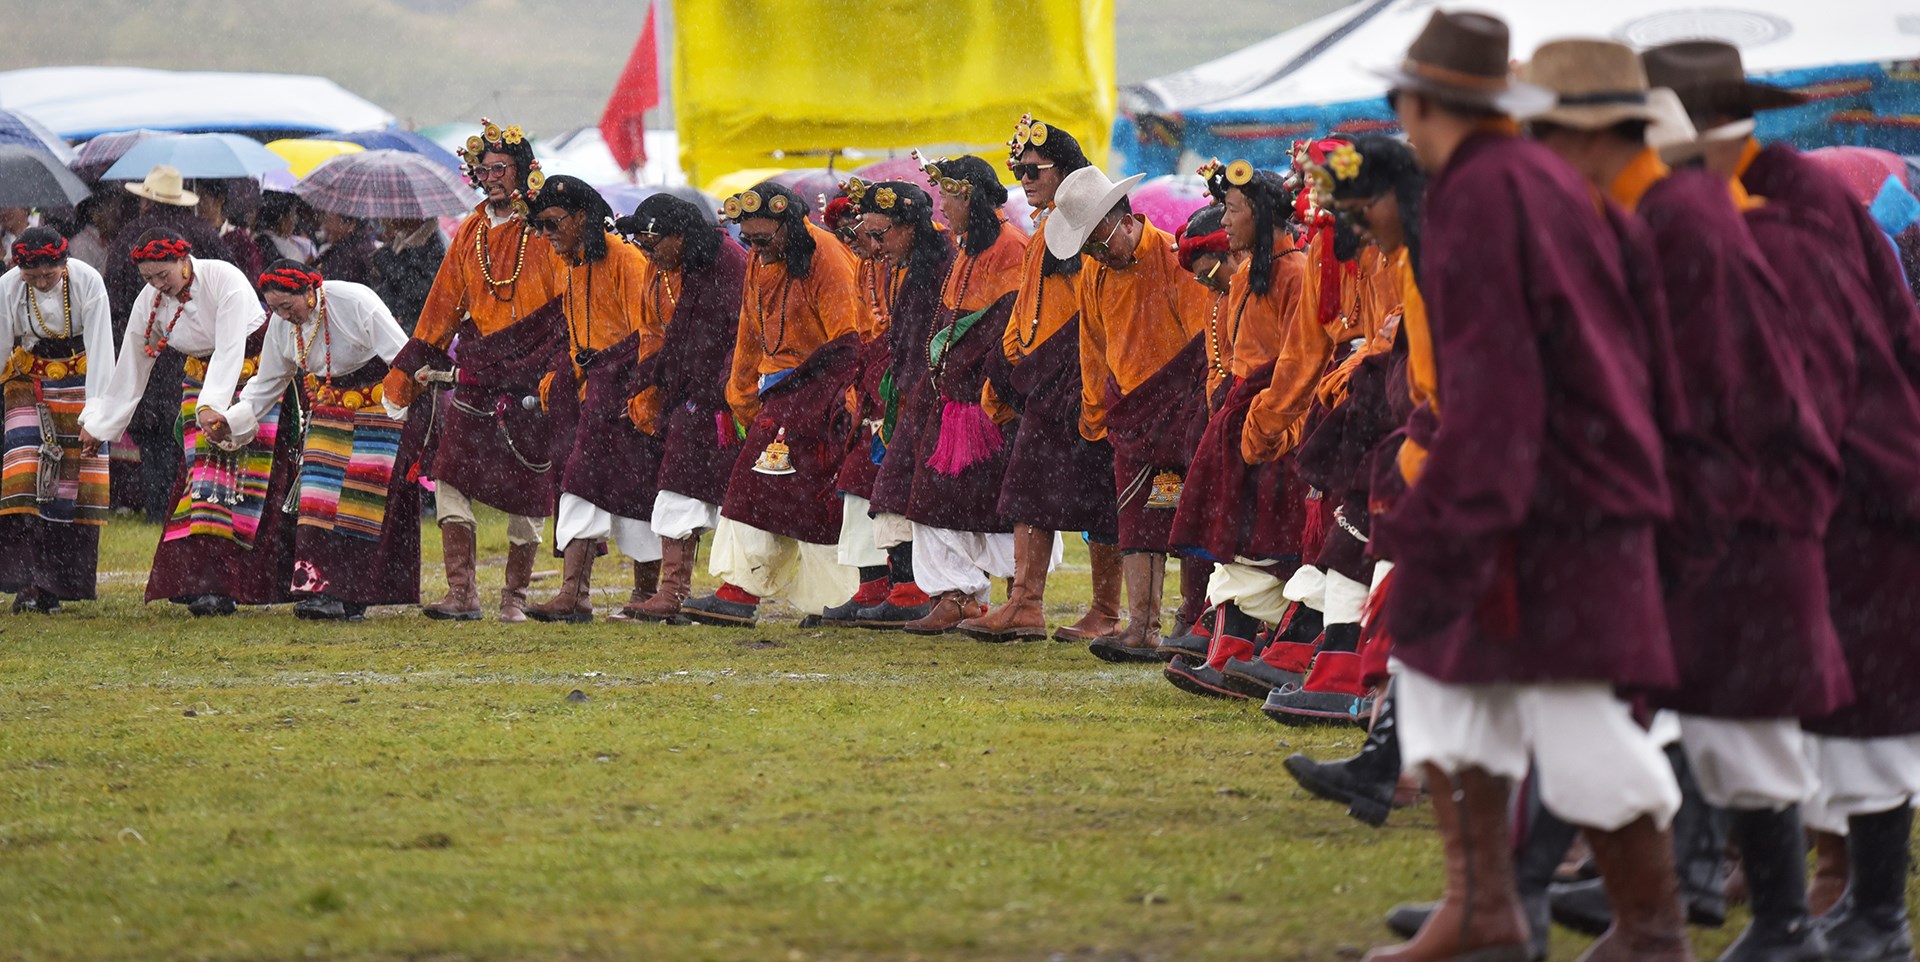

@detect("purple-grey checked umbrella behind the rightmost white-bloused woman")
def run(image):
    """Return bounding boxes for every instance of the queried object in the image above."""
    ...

[294,150,480,219]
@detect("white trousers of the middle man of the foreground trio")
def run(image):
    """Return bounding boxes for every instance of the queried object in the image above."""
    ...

[1680,714,1816,810]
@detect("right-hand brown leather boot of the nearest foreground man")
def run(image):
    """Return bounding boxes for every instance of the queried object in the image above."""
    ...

[1580,816,1693,962]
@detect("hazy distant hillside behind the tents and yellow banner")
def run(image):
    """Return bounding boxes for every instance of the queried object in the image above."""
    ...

[26,0,1344,134]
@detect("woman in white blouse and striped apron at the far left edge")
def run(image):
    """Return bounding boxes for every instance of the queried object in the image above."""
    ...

[0,227,113,614]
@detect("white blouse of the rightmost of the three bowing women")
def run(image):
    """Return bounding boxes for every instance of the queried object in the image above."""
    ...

[227,280,407,445]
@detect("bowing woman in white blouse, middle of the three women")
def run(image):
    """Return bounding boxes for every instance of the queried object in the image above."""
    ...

[81,228,296,614]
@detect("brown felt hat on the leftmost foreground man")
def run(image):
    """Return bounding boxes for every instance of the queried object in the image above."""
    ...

[1373,10,1553,115]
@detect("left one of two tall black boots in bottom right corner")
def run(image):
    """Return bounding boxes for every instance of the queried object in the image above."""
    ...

[1720,805,1827,962]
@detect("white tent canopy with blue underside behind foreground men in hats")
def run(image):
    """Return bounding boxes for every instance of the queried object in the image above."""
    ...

[1116,0,1920,171]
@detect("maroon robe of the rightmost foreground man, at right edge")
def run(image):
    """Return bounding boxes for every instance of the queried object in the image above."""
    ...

[1743,146,1920,737]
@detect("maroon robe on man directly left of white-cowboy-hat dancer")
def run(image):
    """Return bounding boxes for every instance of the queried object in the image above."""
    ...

[987,317,1119,541]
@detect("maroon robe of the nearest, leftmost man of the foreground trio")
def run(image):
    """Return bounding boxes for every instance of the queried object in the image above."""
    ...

[1373,132,1674,687]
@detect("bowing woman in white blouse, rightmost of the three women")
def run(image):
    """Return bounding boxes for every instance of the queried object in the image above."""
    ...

[207,259,430,620]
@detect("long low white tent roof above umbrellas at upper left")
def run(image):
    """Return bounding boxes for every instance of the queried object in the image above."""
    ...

[0,67,394,140]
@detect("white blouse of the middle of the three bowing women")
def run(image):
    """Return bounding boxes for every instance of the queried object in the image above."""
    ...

[81,257,267,440]
